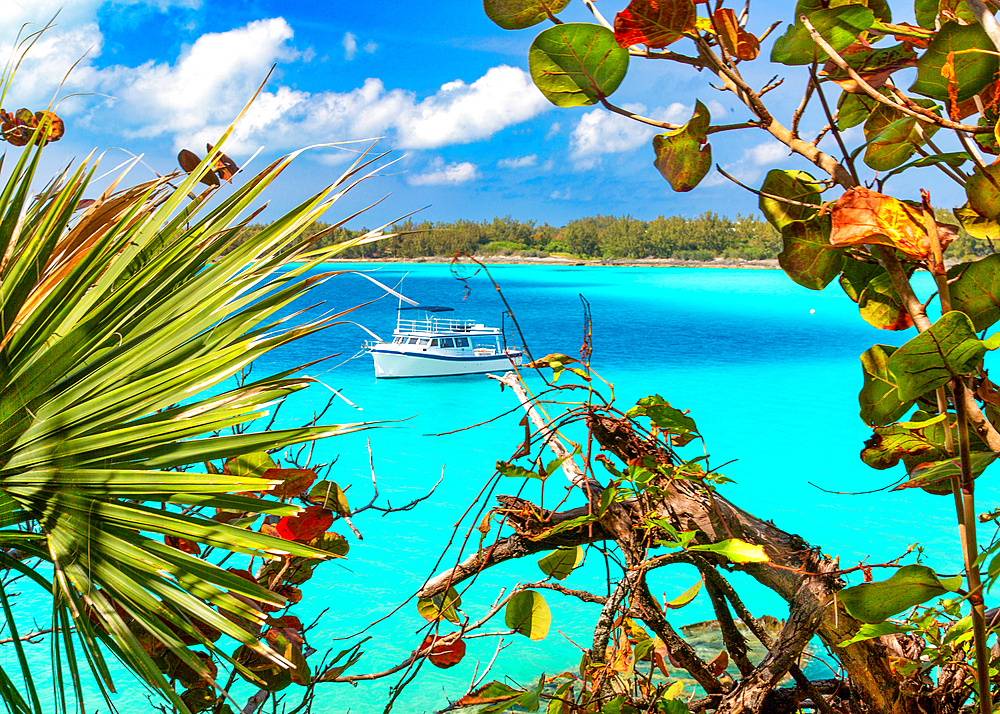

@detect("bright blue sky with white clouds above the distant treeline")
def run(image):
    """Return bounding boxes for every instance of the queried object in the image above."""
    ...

[3,0,968,227]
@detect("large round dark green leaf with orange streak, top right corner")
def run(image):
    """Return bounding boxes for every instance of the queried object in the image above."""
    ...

[910,21,1000,102]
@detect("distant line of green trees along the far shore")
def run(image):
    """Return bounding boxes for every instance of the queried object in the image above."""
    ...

[236,211,990,260]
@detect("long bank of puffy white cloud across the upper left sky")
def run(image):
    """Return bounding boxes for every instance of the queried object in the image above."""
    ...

[0,9,549,156]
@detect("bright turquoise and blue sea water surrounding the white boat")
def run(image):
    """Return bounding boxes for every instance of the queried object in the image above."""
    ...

[23,264,998,714]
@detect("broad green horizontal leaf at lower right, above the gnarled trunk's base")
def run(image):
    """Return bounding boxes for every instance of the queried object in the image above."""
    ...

[837,565,962,624]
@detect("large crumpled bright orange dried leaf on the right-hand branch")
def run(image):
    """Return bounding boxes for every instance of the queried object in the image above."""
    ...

[830,186,958,260]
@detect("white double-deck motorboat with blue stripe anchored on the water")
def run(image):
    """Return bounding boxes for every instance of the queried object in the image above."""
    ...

[364,305,522,378]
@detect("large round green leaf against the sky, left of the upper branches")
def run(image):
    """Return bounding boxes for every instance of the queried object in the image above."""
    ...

[528,22,628,107]
